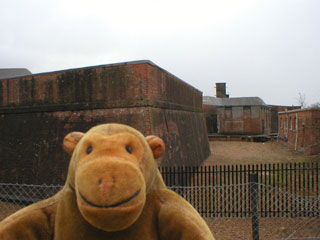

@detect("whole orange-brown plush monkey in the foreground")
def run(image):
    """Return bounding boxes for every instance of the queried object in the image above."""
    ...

[0,124,214,240]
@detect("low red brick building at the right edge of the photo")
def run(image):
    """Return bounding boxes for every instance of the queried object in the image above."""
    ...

[279,109,320,155]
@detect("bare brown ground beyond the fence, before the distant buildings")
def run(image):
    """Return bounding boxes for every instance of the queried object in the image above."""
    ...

[203,141,320,165]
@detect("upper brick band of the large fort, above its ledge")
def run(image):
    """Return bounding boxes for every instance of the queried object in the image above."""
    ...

[0,62,202,112]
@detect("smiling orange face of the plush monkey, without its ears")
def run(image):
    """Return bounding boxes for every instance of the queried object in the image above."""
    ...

[75,133,146,231]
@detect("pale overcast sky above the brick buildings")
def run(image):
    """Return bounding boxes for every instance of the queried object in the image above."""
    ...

[0,0,320,105]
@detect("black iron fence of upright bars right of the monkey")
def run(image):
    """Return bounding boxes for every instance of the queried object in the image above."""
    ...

[160,162,320,217]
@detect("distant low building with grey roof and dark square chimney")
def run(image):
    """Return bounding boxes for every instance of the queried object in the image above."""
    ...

[203,83,271,135]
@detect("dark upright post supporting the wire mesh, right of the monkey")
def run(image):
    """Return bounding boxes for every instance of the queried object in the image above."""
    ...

[249,173,259,240]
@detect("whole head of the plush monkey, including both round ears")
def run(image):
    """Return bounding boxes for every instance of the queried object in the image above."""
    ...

[63,124,165,232]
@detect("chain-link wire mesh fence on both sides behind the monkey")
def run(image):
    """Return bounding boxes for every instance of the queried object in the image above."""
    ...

[0,182,320,240]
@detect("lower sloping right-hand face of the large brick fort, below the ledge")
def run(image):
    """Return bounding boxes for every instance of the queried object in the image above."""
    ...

[151,108,210,166]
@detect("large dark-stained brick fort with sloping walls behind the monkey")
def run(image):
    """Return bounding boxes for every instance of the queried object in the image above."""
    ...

[0,61,210,184]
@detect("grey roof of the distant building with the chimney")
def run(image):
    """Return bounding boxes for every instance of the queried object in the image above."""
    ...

[203,96,267,107]
